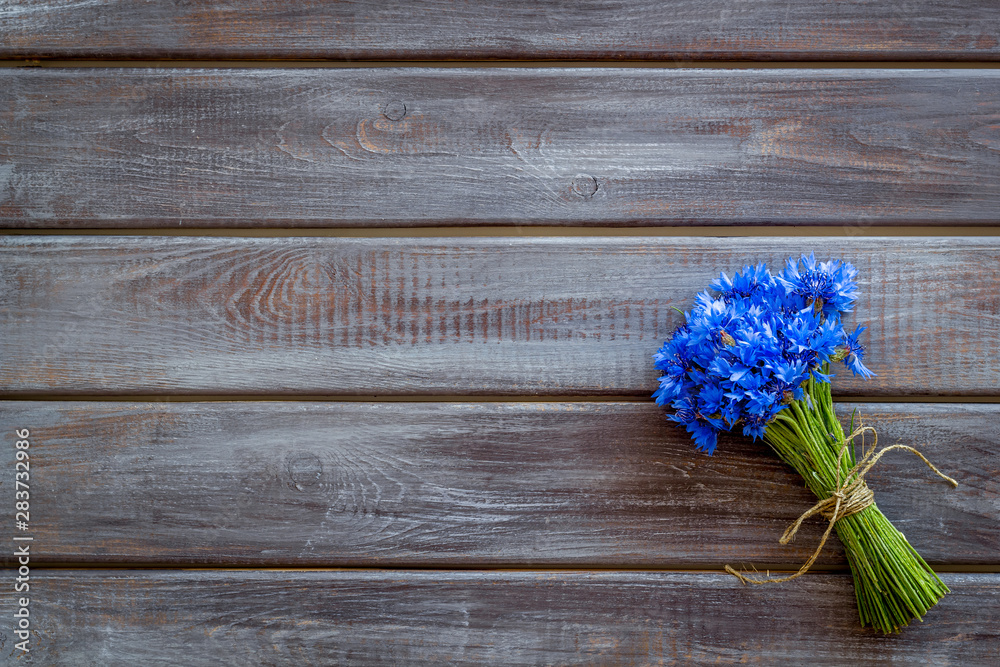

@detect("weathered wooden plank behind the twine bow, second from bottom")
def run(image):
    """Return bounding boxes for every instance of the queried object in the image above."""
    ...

[0,402,1000,569]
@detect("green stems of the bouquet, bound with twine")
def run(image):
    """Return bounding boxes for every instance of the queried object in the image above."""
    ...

[764,365,948,633]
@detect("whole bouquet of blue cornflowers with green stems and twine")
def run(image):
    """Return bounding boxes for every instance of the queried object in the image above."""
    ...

[653,254,957,633]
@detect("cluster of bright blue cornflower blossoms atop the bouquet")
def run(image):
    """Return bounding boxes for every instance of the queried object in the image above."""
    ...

[653,253,874,454]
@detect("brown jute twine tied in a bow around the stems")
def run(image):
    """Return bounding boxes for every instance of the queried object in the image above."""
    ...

[726,426,958,584]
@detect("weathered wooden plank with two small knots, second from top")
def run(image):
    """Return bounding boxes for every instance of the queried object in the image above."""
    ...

[0,69,1000,229]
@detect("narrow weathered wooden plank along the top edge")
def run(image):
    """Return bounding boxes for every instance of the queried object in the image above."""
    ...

[0,0,1000,60]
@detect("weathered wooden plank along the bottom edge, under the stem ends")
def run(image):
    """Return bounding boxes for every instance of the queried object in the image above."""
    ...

[13,570,1000,667]
